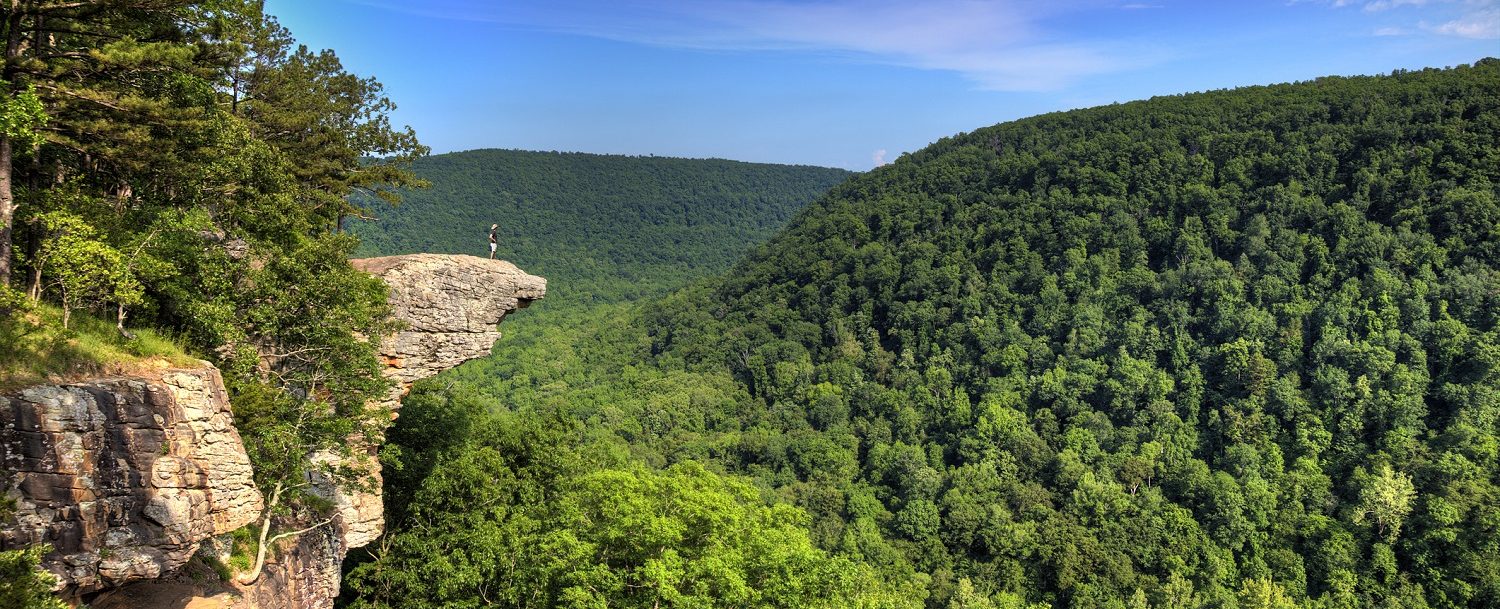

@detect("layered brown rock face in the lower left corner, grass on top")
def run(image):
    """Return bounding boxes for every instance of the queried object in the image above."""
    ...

[0,363,263,593]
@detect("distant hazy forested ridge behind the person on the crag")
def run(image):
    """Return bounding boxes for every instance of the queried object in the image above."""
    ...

[350,150,851,308]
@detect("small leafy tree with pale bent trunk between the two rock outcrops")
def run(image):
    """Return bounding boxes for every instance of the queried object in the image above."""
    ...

[227,234,396,582]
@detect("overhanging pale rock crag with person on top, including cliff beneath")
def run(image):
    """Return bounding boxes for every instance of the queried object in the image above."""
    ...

[246,254,548,609]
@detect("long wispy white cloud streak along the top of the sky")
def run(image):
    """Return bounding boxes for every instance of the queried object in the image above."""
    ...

[345,0,1167,90]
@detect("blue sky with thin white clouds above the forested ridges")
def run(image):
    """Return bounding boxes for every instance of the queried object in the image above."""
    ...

[266,0,1500,171]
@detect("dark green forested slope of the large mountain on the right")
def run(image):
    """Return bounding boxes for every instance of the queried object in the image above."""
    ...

[669,60,1500,606]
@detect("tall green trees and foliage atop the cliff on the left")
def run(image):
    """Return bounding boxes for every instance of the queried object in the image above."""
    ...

[0,0,426,591]
